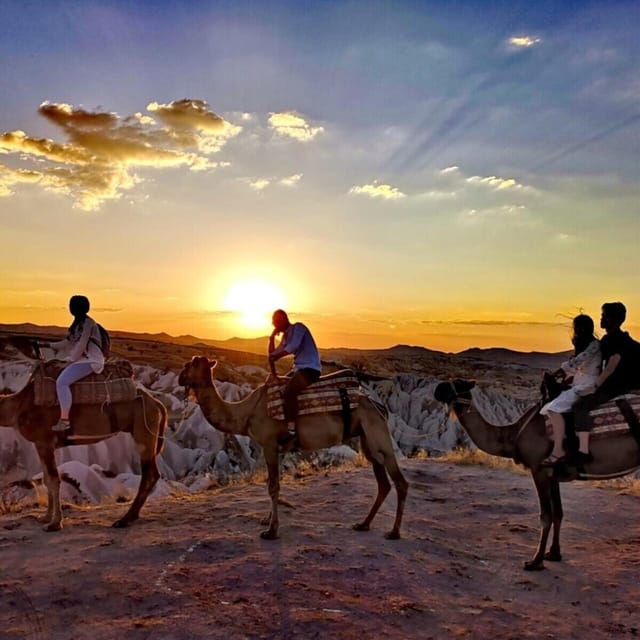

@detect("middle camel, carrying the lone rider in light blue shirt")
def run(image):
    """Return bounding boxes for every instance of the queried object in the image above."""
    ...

[178,356,408,540]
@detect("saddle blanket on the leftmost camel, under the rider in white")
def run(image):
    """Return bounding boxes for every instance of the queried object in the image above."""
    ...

[32,360,137,407]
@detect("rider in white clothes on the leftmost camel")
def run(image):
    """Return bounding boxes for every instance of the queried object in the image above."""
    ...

[49,296,105,431]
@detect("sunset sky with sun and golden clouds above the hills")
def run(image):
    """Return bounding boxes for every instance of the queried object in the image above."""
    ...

[0,0,640,352]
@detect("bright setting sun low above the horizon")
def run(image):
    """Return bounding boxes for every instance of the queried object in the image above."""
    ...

[222,279,286,329]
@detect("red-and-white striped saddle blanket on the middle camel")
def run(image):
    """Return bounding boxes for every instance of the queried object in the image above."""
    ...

[267,370,360,420]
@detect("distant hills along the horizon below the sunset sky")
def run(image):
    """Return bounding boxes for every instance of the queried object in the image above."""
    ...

[0,322,571,369]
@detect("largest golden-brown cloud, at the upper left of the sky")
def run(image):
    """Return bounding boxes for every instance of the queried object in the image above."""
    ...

[0,99,242,211]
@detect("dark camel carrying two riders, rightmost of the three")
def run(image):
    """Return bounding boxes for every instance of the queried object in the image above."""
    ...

[434,380,640,571]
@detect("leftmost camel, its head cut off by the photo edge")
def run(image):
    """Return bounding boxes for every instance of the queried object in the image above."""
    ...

[0,341,167,531]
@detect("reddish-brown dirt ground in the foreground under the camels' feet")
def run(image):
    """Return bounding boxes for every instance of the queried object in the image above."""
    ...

[0,459,640,640]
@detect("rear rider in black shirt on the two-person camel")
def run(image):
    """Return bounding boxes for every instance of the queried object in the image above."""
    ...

[574,302,640,463]
